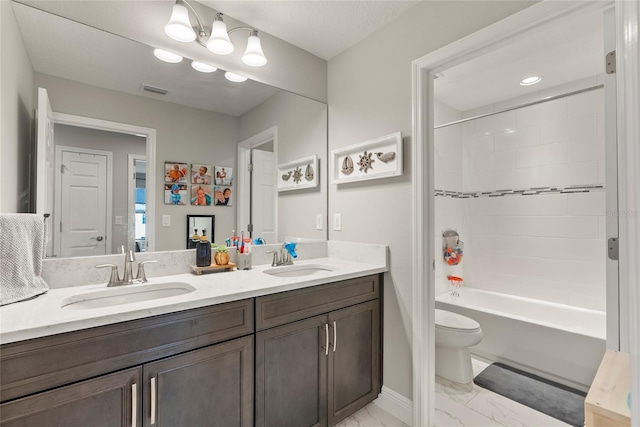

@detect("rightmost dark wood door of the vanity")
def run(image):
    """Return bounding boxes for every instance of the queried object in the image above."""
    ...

[328,300,380,425]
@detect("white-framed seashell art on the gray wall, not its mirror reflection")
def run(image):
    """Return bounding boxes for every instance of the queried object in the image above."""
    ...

[329,132,402,184]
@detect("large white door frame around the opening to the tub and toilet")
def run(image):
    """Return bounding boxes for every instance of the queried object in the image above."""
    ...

[411,0,640,426]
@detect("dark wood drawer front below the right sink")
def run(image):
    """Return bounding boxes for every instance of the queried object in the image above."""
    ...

[256,275,380,330]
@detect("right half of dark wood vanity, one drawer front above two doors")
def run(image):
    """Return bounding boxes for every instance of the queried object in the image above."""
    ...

[255,276,381,427]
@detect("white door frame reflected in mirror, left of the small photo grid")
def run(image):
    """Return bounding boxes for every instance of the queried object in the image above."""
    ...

[53,112,158,252]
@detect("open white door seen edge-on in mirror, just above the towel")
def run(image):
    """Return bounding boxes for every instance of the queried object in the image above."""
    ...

[35,87,54,255]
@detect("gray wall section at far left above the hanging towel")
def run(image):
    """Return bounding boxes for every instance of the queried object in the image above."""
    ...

[0,1,35,213]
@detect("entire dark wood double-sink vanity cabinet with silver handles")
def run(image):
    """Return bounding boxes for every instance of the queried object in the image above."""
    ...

[0,275,381,427]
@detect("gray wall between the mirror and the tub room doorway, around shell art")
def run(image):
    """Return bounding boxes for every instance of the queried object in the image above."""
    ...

[328,1,533,398]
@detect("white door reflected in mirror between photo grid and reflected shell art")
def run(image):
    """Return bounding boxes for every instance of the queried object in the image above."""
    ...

[251,149,278,243]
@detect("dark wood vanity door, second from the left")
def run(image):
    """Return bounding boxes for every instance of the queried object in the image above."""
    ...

[144,336,253,427]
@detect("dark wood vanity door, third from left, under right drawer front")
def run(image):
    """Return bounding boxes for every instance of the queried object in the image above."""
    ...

[256,315,328,427]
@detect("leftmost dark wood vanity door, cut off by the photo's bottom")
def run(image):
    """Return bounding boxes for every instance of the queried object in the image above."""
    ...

[0,368,142,427]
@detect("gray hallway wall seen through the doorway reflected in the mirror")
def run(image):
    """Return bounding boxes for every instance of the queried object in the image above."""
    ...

[54,124,146,254]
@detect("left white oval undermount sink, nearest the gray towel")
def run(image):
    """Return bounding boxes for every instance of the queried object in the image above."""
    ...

[60,282,196,309]
